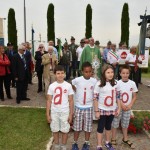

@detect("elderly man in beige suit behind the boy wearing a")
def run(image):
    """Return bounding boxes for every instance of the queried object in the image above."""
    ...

[42,46,58,95]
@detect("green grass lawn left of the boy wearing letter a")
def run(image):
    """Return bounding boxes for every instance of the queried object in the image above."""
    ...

[0,107,51,150]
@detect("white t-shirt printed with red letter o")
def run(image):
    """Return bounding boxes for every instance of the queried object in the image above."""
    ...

[118,80,138,105]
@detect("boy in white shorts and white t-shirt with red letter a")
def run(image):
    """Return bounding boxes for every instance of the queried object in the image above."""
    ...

[46,66,74,150]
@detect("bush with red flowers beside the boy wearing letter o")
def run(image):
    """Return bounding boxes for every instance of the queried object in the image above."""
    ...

[128,112,150,134]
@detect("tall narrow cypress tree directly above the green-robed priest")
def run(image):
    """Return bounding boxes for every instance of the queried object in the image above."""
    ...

[85,4,92,38]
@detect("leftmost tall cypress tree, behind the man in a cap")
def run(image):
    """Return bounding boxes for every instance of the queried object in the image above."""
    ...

[8,8,17,50]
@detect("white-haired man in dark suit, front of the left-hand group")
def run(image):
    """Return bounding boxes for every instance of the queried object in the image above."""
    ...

[12,45,30,104]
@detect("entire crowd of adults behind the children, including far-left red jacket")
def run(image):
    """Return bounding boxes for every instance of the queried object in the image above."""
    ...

[0,36,142,104]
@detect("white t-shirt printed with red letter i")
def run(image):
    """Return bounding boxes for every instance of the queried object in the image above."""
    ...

[72,76,97,108]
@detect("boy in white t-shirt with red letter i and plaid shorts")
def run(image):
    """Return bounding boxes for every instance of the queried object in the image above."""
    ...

[72,62,97,150]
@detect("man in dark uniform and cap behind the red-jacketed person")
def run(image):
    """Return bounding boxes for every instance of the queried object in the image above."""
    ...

[5,42,16,87]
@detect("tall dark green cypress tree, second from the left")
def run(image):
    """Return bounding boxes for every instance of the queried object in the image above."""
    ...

[47,3,55,43]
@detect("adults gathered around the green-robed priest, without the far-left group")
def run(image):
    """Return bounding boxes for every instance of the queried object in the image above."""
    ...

[35,37,142,94]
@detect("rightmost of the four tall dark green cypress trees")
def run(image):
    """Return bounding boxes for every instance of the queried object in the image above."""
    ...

[121,3,129,47]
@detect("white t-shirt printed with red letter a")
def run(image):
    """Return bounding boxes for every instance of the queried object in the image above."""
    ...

[47,81,74,112]
